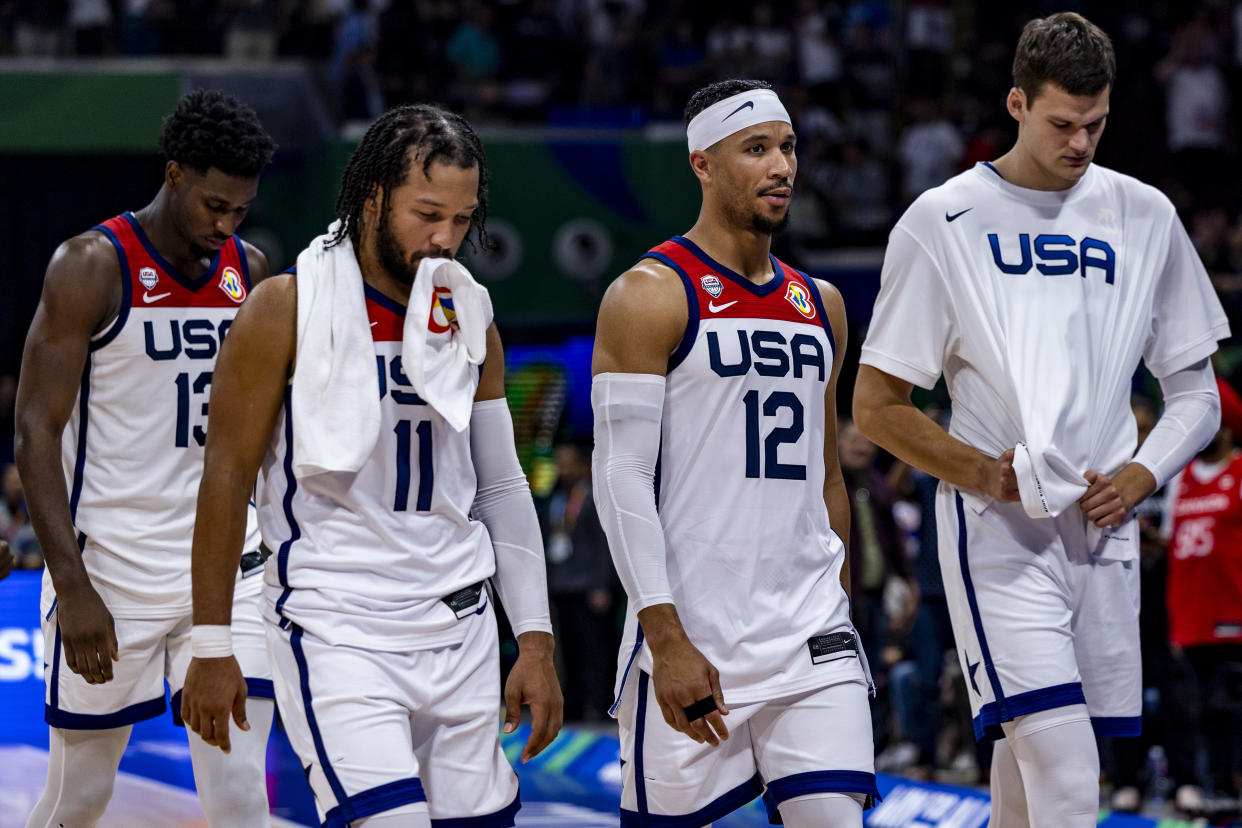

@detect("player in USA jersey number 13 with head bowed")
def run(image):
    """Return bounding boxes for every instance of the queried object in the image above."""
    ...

[16,91,276,828]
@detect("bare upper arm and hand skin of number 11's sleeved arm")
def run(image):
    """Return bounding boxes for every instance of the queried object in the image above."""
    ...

[474,323,565,762]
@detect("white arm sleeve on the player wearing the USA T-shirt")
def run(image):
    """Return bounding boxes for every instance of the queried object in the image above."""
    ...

[1134,360,1221,489]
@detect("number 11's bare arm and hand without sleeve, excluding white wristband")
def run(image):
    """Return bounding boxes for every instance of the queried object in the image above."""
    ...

[181,276,297,752]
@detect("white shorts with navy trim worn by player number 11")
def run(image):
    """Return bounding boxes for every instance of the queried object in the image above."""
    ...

[267,601,520,828]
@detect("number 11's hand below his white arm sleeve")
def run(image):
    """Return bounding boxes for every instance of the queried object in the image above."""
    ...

[504,632,565,762]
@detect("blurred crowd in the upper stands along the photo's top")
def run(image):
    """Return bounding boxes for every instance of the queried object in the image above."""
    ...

[7,0,1242,255]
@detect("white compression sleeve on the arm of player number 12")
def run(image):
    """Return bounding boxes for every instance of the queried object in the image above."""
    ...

[591,374,673,612]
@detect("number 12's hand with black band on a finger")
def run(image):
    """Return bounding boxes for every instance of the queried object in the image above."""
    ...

[651,636,729,747]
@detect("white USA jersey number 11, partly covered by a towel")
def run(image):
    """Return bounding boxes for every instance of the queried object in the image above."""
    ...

[258,286,496,652]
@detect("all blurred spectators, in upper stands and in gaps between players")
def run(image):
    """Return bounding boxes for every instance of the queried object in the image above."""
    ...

[0,0,1242,813]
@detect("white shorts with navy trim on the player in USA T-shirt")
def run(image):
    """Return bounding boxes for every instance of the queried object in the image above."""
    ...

[936,483,1143,740]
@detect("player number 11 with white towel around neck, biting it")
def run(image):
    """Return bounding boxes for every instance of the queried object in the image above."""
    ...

[184,106,561,828]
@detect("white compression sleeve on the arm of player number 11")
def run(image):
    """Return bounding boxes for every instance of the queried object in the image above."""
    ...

[469,397,551,636]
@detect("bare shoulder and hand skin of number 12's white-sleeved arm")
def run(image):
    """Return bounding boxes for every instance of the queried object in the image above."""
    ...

[591,259,729,745]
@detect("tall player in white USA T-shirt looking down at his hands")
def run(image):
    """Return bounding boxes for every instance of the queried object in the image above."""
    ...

[854,12,1228,828]
